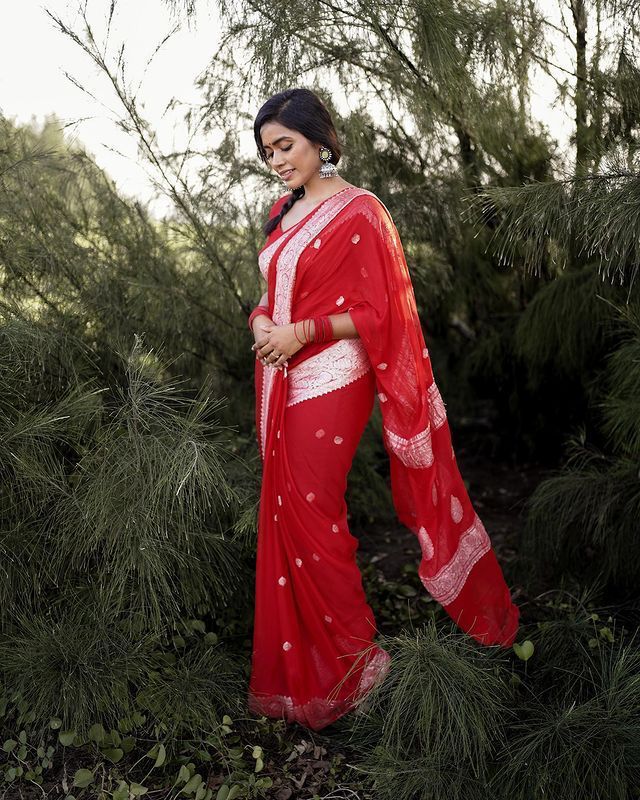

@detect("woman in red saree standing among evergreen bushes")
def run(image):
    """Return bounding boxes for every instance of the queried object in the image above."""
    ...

[249,89,519,730]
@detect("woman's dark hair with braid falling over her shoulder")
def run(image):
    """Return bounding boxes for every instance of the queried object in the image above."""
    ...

[253,89,342,236]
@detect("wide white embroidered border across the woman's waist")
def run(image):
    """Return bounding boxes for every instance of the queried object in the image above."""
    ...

[287,339,371,406]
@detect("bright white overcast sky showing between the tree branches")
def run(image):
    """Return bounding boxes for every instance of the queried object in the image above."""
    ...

[0,0,571,213]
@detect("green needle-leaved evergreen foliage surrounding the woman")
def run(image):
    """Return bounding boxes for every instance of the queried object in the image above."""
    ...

[0,0,640,800]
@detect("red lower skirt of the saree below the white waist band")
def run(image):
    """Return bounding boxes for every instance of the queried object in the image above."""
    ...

[249,360,388,730]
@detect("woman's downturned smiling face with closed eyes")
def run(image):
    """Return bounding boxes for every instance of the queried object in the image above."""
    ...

[260,122,322,189]
